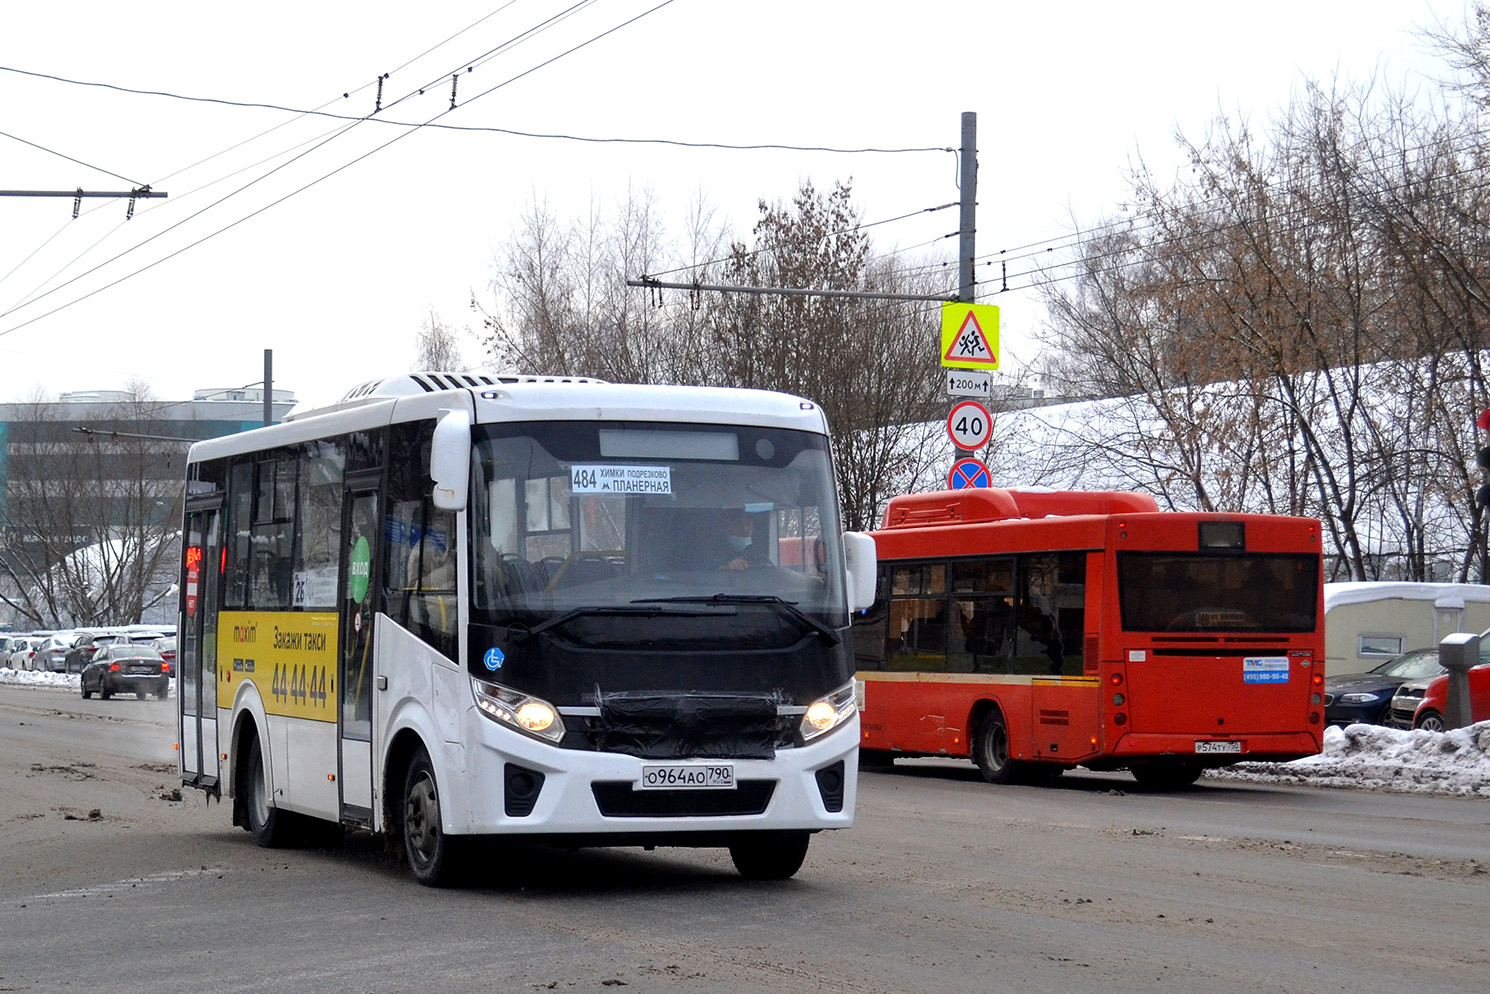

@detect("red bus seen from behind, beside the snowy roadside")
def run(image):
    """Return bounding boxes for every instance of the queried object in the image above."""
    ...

[854,487,1325,787]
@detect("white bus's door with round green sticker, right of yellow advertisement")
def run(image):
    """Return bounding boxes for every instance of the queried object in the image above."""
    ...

[337,482,383,826]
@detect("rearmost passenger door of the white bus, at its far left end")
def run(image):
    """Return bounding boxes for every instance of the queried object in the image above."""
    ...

[176,501,224,793]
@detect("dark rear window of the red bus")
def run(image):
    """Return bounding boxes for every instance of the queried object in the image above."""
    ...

[1118,551,1319,632]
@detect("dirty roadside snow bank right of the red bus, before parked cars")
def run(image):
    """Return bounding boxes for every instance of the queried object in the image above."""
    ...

[1205,721,1490,797]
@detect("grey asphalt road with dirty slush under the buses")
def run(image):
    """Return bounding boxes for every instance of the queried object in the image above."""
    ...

[0,687,1490,994]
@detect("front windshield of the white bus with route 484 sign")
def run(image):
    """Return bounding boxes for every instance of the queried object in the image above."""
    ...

[471,422,848,629]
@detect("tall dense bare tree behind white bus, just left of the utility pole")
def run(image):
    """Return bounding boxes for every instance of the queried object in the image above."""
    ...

[712,182,946,529]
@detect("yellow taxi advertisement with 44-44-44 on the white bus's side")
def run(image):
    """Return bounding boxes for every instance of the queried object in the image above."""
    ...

[218,611,338,721]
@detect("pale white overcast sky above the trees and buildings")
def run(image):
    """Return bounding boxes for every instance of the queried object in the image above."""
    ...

[0,0,1466,402]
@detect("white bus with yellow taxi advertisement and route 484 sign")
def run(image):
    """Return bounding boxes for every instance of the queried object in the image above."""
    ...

[177,373,875,885]
